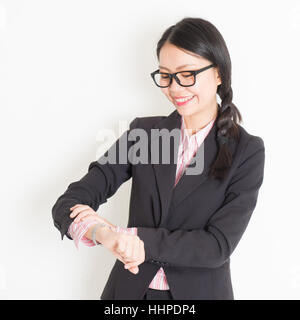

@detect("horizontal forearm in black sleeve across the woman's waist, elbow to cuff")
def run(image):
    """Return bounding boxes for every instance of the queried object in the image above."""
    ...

[138,227,230,268]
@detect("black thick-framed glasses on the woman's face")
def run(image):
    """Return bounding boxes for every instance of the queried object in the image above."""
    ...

[150,64,216,88]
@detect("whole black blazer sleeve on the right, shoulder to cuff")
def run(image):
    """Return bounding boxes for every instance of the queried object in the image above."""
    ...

[137,136,265,268]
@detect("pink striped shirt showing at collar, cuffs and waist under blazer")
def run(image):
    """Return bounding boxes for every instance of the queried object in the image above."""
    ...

[68,116,215,290]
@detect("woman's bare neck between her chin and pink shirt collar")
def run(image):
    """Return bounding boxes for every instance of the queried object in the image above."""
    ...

[183,103,218,135]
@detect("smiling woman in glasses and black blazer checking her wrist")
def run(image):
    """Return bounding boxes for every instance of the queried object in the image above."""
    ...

[52,18,265,300]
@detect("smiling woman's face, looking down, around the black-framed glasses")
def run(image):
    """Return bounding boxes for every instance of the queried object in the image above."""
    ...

[159,43,221,116]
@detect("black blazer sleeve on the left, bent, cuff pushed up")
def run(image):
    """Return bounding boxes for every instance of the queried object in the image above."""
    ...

[52,118,138,240]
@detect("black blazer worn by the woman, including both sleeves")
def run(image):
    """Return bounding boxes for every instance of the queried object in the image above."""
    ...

[52,110,265,300]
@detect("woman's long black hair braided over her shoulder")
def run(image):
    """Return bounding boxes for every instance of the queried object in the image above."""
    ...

[156,17,242,180]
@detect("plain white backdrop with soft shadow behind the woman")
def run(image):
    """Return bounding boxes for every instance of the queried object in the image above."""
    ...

[0,0,300,300]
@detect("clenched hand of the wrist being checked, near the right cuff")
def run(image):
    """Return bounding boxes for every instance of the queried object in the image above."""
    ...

[97,228,145,274]
